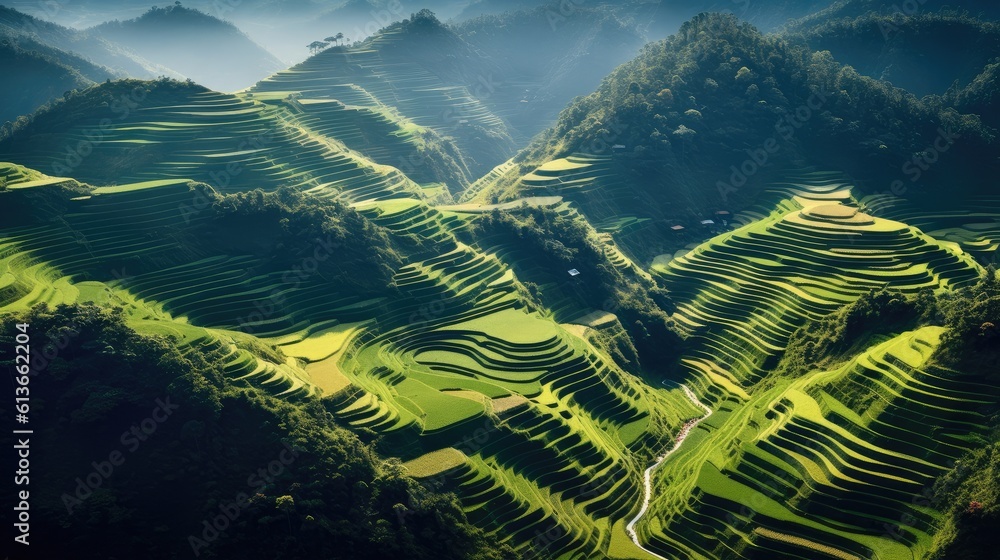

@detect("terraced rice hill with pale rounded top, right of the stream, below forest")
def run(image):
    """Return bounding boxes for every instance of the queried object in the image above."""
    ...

[653,174,981,392]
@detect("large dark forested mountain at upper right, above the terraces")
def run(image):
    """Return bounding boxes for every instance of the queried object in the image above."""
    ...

[464,15,996,259]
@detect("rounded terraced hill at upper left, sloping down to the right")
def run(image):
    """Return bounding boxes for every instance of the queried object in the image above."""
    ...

[0,79,419,200]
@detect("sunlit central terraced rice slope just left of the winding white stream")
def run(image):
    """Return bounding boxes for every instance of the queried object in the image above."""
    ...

[318,202,699,558]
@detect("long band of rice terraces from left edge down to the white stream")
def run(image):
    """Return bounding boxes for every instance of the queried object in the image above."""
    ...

[0,161,712,558]
